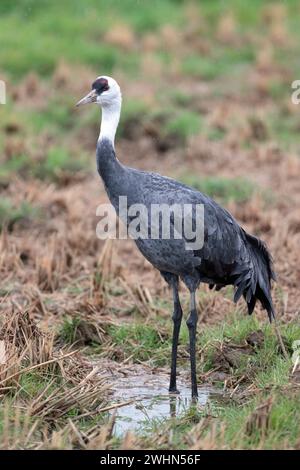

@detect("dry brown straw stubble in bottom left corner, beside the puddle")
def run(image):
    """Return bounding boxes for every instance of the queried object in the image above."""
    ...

[0,310,110,449]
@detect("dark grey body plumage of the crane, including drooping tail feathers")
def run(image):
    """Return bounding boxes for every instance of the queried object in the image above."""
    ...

[97,139,275,320]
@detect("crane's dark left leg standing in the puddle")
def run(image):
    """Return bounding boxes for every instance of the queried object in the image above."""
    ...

[169,279,182,393]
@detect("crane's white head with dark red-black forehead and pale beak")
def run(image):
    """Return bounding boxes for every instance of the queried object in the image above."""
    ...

[76,75,122,108]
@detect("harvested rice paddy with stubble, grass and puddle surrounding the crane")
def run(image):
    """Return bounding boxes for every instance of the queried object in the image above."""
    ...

[0,0,300,450]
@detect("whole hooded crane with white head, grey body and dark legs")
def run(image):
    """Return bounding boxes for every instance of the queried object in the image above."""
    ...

[77,76,275,397]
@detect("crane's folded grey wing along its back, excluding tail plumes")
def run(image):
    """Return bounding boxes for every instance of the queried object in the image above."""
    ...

[129,170,251,284]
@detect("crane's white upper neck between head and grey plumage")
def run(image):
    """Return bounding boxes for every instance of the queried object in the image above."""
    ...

[98,96,122,147]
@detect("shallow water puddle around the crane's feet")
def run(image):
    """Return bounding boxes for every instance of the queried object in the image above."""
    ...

[101,365,215,436]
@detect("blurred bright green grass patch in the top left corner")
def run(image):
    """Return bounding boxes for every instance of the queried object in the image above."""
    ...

[0,0,182,79]
